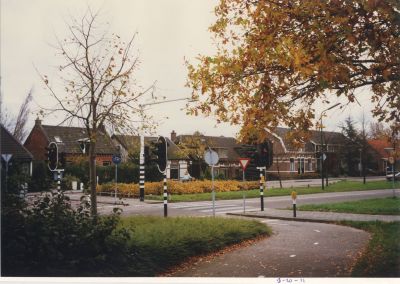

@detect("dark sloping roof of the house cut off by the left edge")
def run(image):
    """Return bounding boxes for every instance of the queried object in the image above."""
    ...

[0,125,33,161]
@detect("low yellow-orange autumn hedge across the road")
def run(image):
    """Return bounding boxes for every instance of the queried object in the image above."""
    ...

[97,180,259,196]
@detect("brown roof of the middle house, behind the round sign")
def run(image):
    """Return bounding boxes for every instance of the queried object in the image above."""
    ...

[177,135,241,161]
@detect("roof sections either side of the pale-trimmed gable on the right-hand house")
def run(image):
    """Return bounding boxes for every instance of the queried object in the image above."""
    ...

[274,127,346,151]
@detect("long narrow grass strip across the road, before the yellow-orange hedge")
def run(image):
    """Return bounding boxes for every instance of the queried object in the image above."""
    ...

[145,181,399,202]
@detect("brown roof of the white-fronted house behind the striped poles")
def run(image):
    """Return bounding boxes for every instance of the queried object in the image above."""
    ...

[112,134,188,160]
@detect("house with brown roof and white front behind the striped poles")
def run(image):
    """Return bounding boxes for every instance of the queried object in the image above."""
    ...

[111,135,189,179]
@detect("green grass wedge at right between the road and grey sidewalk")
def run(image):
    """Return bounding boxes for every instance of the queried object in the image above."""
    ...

[298,197,400,215]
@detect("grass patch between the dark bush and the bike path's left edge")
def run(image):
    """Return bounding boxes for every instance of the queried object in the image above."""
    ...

[120,216,271,276]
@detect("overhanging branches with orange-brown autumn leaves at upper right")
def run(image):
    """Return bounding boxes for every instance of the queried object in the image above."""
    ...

[187,0,400,142]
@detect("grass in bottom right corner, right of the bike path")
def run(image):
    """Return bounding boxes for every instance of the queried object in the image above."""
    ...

[339,221,400,277]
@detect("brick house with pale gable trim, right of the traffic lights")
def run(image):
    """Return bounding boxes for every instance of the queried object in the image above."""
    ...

[267,127,346,177]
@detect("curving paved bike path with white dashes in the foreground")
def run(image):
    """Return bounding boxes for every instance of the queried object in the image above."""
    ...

[171,219,369,277]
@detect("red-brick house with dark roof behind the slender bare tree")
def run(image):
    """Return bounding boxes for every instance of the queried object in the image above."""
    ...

[24,119,117,166]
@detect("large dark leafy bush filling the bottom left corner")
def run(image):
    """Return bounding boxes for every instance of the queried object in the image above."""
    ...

[1,191,131,276]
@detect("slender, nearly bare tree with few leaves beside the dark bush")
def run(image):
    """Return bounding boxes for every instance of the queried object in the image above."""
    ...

[38,8,154,217]
